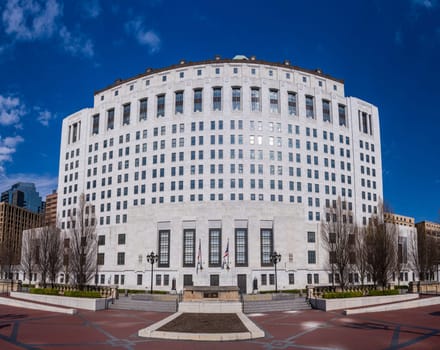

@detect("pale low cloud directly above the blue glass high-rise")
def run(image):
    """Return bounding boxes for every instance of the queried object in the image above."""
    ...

[0,171,58,200]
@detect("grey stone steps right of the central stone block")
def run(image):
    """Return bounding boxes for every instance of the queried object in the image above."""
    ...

[243,297,312,314]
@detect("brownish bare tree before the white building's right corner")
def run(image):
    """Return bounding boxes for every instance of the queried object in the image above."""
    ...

[365,205,397,287]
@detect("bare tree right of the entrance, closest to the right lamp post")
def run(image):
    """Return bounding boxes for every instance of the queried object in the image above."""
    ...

[321,198,356,288]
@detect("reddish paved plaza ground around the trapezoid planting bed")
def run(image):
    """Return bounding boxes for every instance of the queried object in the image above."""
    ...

[0,305,440,350]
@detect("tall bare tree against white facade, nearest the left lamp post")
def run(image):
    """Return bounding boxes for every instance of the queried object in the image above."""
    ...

[65,194,97,290]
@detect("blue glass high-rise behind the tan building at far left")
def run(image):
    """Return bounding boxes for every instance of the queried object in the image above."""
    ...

[1,182,44,213]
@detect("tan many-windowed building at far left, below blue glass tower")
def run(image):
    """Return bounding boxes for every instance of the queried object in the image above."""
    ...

[0,202,42,278]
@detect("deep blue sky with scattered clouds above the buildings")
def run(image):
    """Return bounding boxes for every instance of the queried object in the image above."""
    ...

[0,0,440,221]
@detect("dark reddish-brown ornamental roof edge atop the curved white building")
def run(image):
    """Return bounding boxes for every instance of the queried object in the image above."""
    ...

[94,56,344,95]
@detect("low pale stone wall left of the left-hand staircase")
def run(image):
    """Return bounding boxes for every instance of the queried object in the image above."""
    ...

[10,292,107,311]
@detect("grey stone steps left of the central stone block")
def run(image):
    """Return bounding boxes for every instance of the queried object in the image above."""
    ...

[109,296,177,312]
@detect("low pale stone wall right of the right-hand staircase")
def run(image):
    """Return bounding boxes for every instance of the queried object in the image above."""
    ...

[309,294,419,311]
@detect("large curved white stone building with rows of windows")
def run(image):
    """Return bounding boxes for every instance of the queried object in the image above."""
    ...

[57,56,382,292]
